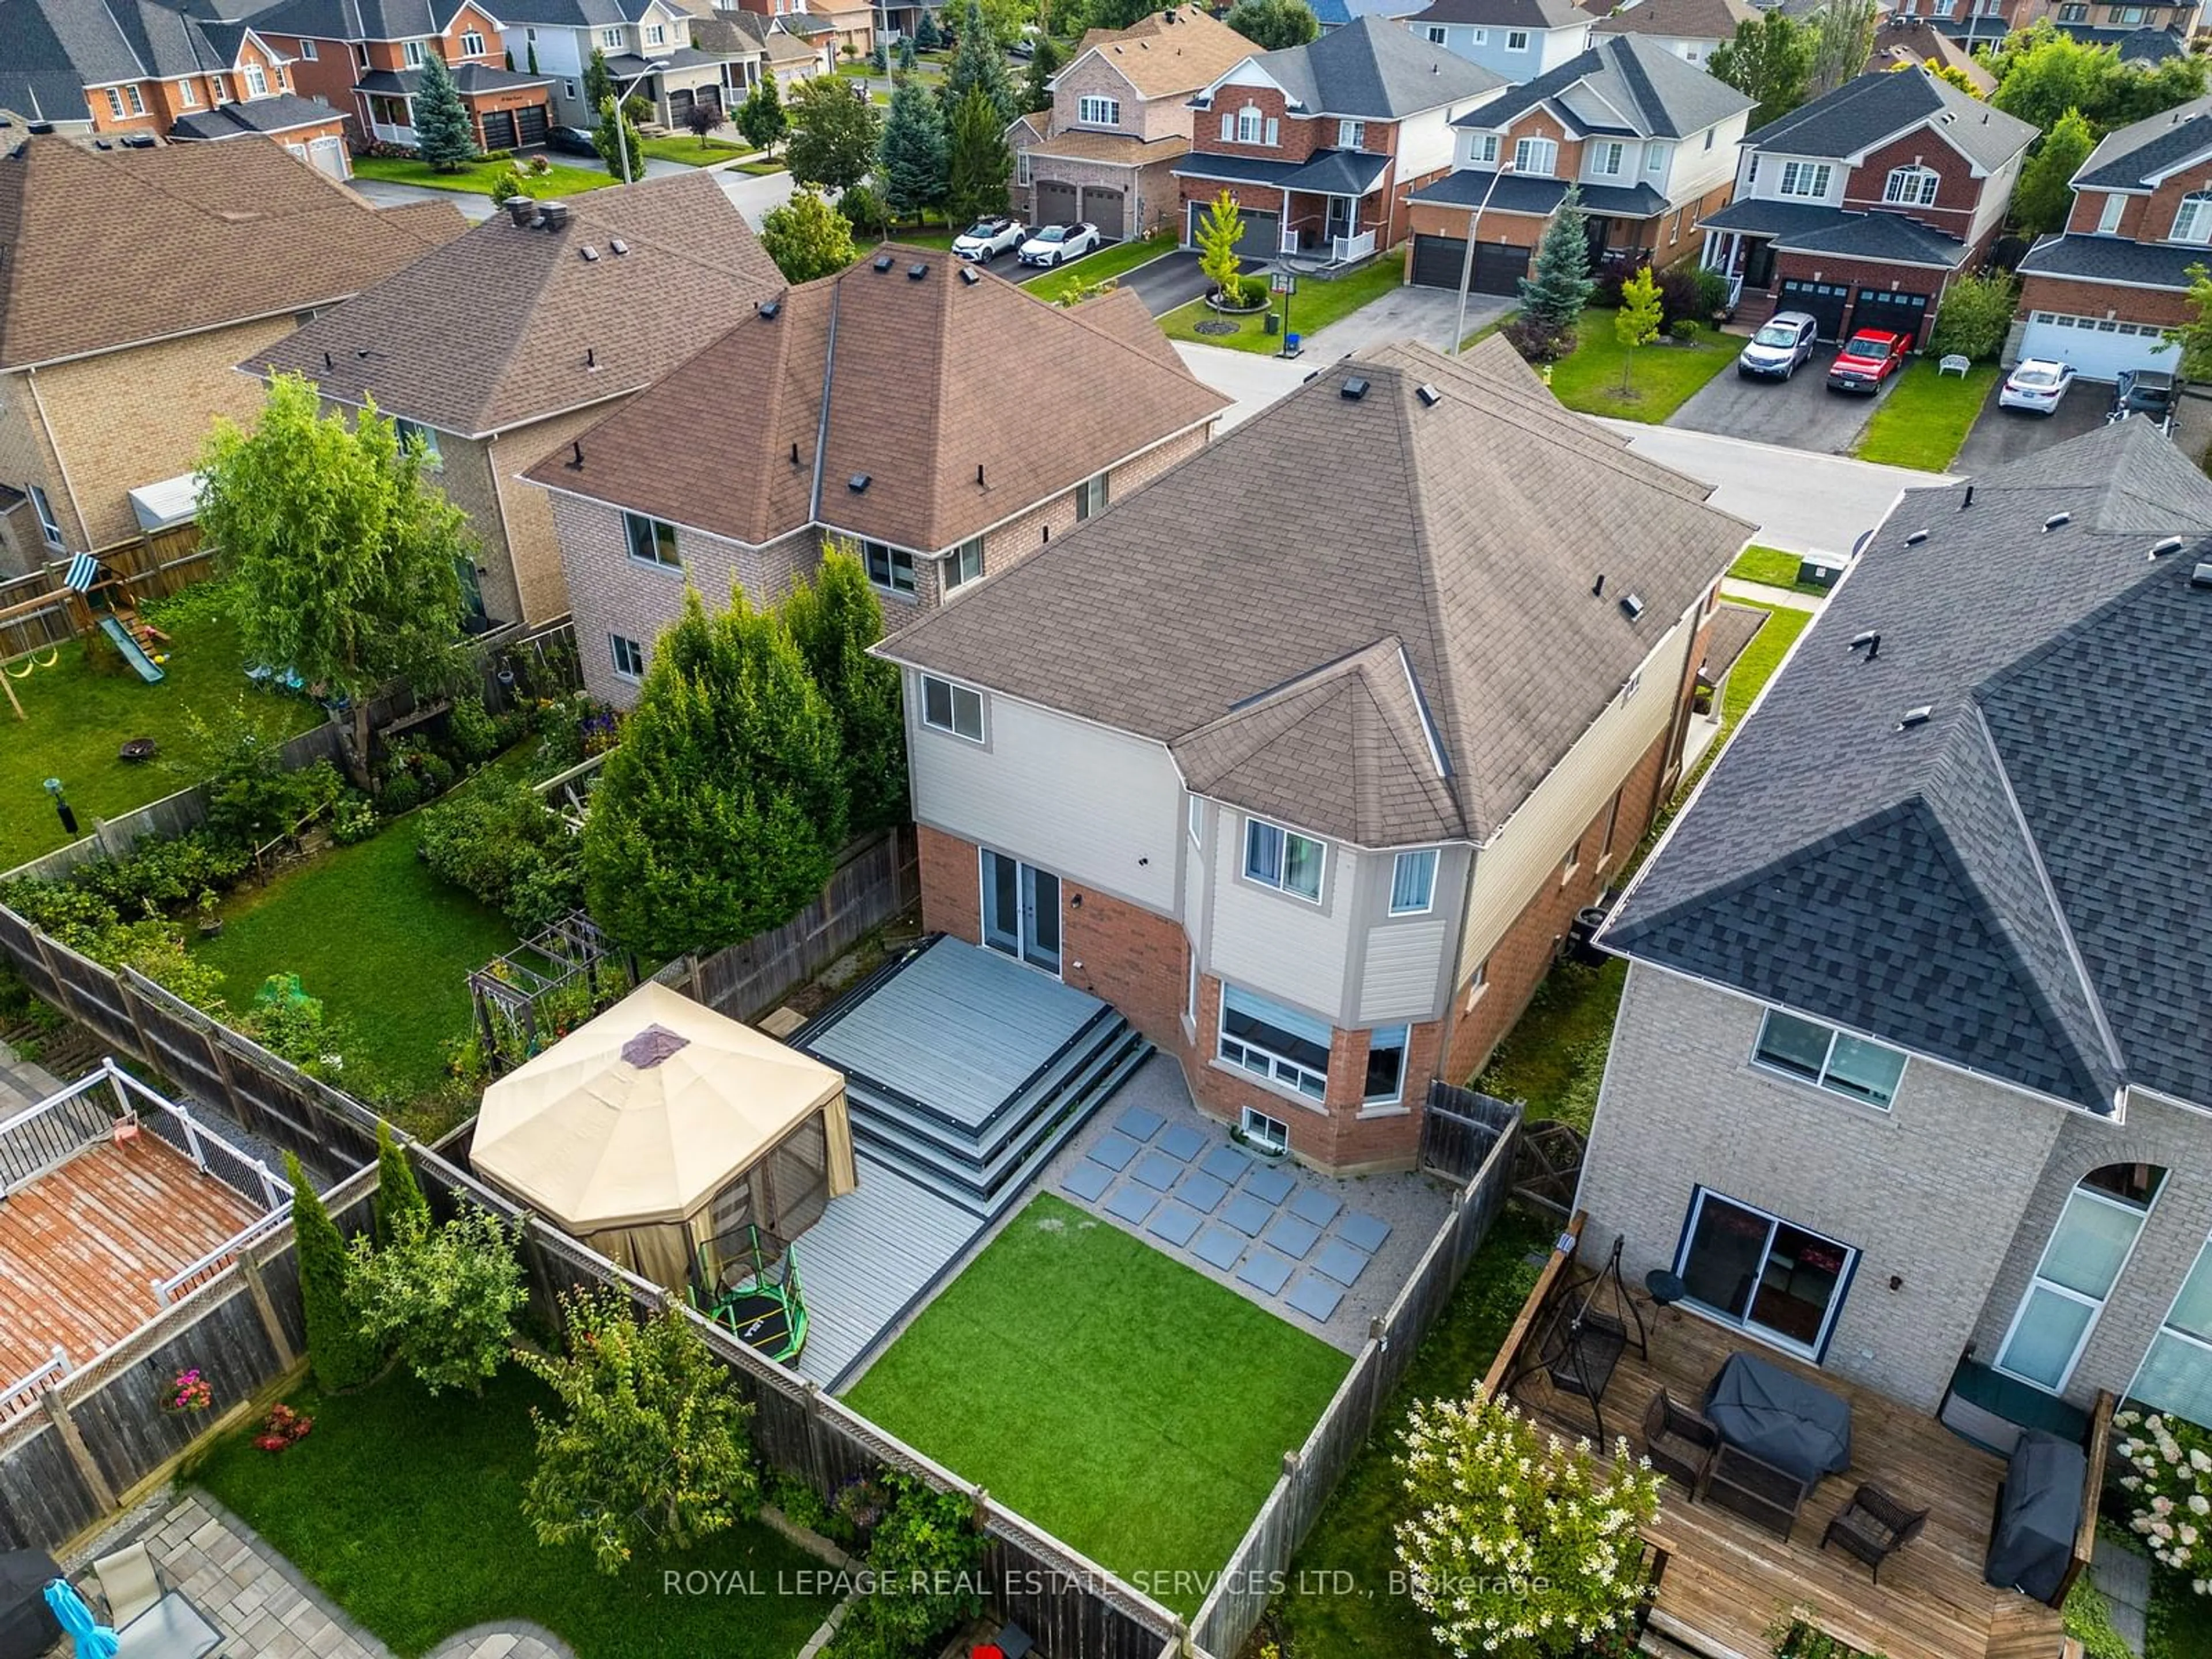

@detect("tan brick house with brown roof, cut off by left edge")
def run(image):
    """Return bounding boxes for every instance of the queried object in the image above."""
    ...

[0,137,464,571]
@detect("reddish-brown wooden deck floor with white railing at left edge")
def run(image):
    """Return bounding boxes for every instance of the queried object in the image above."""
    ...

[0,1135,261,1382]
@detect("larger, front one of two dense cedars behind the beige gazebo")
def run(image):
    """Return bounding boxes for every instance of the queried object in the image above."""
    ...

[584,588,850,958]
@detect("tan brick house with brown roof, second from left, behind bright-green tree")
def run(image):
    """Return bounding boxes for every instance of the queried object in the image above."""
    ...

[252,173,783,626]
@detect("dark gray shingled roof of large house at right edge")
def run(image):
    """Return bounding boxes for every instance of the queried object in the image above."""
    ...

[1604,421,2212,1113]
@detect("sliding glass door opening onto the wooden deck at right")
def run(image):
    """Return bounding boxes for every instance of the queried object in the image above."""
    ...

[1675,1188,1858,1358]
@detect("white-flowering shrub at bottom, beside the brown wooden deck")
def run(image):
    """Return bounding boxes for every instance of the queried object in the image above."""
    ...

[1396,1400,1659,1659]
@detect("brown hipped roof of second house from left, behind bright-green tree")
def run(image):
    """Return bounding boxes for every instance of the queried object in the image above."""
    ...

[241,173,783,434]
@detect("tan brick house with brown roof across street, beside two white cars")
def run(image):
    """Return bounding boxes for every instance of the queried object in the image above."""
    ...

[1006,5,1259,239]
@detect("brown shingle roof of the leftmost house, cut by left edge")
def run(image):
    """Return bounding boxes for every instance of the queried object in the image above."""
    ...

[0,137,451,367]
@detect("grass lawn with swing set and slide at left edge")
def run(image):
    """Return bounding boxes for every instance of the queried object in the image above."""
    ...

[0,606,323,869]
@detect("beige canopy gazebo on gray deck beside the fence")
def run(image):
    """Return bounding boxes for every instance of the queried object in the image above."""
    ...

[469,980,854,1292]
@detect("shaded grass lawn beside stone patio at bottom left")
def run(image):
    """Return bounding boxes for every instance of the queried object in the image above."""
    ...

[192,1365,830,1659]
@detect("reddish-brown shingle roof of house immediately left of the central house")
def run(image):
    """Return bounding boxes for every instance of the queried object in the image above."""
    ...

[529,245,1225,553]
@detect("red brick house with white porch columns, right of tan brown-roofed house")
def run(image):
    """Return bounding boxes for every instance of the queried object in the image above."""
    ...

[1175,16,1506,266]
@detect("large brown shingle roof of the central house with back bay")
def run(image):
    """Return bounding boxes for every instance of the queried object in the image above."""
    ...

[882,339,1749,845]
